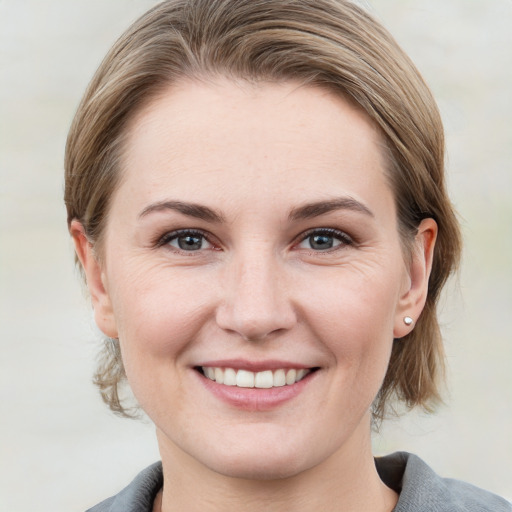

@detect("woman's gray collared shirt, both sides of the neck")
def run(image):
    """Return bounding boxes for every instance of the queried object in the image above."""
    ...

[87,452,512,512]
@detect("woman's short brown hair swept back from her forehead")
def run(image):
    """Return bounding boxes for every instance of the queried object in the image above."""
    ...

[65,0,461,418]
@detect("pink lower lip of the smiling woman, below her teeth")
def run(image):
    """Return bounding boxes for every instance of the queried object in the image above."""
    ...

[194,370,318,411]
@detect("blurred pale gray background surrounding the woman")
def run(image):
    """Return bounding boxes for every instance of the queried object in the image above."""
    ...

[0,0,512,512]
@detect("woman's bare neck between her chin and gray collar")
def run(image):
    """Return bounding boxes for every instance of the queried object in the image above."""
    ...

[158,418,397,512]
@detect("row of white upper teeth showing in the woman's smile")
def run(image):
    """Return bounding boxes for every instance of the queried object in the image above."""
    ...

[202,366,311,389]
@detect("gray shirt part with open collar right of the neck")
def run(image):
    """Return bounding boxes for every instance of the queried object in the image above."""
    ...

[375,452,512,512]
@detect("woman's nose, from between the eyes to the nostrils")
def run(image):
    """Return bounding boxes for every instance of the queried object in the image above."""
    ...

[216,253,296,341]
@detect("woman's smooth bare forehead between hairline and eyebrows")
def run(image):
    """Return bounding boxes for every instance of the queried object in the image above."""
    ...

[117,79,389,216]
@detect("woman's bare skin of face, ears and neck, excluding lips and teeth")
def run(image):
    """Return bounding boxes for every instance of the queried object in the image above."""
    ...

[71,78,437,512]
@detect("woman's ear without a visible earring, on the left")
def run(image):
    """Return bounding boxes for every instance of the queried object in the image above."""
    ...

[69,220,118,338]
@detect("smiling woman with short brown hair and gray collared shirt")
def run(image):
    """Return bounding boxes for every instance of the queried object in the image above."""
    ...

[65,0,511,512]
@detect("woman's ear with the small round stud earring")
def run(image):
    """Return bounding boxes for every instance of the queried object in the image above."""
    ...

[393,218,437,338]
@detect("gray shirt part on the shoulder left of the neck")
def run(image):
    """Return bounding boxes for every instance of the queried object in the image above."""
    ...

[86,462,163,512]
